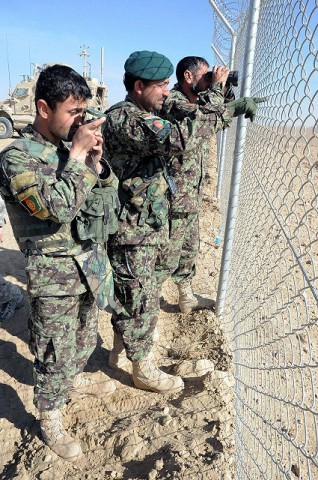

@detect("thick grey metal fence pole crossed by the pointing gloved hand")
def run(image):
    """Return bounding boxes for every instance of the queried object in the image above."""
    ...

[216,0,261,315]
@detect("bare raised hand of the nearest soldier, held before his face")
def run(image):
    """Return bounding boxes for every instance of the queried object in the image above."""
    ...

[69,117,105,163]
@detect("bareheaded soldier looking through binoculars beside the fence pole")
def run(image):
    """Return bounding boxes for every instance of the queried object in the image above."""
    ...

[156,57,264,313]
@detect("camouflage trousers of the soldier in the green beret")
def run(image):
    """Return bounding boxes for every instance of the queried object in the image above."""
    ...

[108,244,165,361]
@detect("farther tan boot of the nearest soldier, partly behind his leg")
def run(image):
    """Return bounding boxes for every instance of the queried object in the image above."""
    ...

[69,372,116,400]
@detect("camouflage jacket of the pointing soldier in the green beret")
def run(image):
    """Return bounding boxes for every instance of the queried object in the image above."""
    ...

[104,95,229,244]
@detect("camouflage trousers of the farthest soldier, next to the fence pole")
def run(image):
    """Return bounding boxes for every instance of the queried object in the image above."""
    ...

[155,212,200,286]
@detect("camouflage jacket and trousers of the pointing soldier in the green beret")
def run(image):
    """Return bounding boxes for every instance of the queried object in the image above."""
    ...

[104,96,230,360]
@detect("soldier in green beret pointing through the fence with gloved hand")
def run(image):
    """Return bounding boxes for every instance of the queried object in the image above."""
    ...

[104,51,234,392]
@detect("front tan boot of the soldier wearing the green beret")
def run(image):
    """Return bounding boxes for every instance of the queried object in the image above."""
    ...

[132,353,184,393]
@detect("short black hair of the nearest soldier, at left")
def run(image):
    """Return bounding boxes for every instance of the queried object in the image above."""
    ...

[35,64,92,110]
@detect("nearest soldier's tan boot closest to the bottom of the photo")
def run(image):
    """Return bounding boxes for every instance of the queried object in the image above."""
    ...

[40,410,82,462]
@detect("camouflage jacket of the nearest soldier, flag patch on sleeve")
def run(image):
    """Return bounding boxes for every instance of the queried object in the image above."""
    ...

[0,125,116,308]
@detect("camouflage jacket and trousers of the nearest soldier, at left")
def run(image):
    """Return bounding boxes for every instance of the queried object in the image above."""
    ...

[0,126,112,410]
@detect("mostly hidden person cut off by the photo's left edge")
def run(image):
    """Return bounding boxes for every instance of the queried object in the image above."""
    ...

[0,197,25,324]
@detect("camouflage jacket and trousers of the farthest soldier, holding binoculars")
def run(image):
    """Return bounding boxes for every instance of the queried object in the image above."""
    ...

[156,84,230,284]
